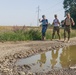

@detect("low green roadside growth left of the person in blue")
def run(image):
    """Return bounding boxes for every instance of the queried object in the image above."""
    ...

[0,29,41,41]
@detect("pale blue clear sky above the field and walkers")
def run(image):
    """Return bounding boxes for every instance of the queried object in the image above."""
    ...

[0,0,64,26]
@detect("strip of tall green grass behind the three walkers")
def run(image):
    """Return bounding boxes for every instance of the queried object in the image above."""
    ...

[0,26,76,41]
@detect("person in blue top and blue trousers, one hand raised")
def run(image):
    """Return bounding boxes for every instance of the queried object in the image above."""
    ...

[39,15,48,40]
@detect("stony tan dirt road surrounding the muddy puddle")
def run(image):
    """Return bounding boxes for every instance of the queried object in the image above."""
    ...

[0,38,76,75]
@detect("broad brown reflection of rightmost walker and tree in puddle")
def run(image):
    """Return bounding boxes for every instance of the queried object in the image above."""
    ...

[60,46,76,68]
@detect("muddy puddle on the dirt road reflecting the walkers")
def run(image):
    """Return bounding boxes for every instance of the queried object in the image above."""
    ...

[16,45,76,72]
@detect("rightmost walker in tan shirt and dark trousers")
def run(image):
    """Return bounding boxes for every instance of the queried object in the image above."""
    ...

[64,13,75,42]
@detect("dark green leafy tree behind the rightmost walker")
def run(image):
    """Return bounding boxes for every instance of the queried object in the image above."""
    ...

[63,0,76,28]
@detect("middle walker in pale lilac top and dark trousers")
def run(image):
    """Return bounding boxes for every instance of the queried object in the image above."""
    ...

[52,14,60,40]
